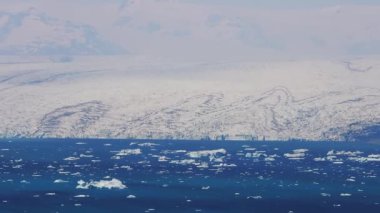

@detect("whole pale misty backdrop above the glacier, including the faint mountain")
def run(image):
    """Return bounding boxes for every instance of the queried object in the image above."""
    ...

[0,0,380,60]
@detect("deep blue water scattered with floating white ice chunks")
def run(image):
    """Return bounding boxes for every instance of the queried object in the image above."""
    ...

[0,139,380,213]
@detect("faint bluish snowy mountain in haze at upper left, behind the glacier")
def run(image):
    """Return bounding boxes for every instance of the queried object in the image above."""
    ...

[0,8,122,55]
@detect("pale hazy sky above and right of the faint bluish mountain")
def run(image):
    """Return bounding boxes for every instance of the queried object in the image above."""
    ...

[0,0,380,58]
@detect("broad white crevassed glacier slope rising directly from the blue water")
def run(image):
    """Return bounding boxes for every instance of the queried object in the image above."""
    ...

[0,57,380,140]
